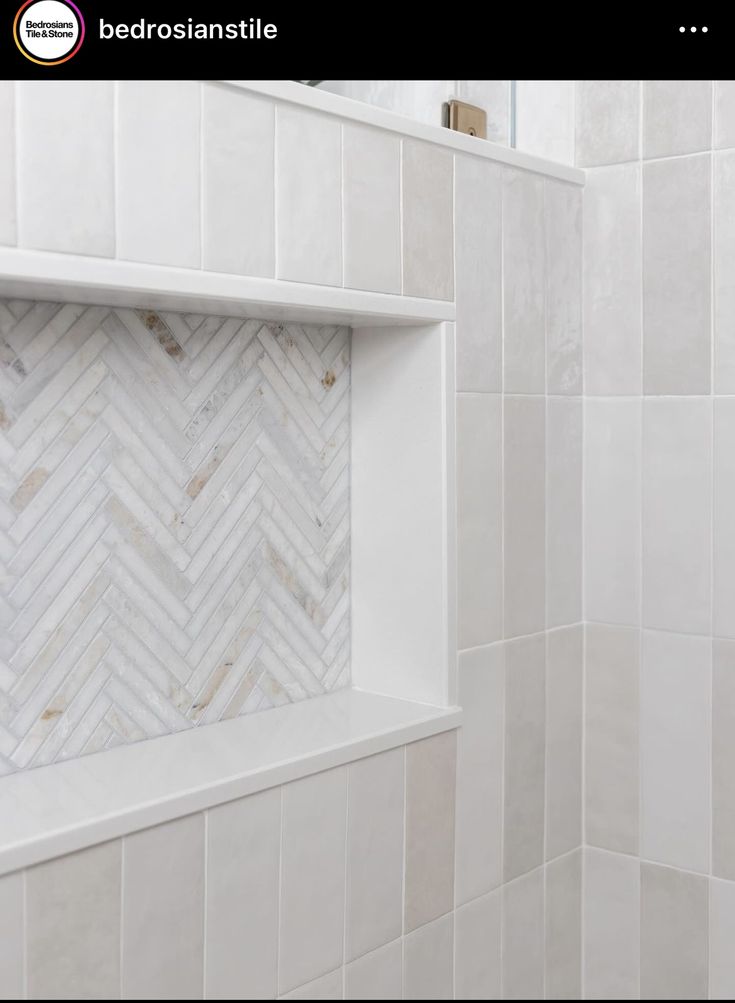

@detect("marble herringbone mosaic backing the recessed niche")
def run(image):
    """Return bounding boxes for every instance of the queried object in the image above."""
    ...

[0,300,350,772]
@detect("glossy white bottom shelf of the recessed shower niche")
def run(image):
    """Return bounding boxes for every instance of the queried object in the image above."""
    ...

[0,689,461,875]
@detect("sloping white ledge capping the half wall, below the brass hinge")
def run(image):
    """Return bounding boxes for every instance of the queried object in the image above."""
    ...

[222,80,585,187]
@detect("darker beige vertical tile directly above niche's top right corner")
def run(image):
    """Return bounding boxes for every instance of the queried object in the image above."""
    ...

[403,139,454,300]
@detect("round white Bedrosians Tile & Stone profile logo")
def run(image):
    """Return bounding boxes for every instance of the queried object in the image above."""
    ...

[13,0,84,66]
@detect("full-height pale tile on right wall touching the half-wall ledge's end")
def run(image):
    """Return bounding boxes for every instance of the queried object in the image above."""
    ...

[583,163,643,395]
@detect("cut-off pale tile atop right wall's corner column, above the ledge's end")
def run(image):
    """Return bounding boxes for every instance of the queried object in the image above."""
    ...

[577,80,641,165]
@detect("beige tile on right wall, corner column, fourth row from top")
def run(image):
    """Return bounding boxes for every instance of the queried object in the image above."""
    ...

[585,624,640,854]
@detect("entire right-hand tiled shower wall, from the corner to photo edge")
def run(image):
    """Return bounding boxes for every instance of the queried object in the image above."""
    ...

[577,80,735,999]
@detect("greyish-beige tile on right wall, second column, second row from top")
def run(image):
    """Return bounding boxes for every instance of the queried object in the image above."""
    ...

[643,154,712,394]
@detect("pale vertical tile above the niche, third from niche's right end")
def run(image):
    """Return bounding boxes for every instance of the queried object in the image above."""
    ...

[276,104,342,286]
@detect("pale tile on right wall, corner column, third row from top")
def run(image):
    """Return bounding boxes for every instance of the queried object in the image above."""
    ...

[584,398,642,624]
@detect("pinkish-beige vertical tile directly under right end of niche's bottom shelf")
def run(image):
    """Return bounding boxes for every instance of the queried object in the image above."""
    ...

[404,731,457,931]
